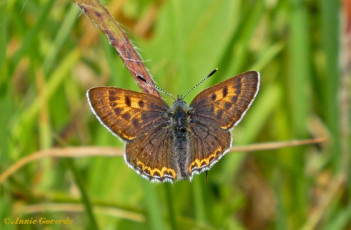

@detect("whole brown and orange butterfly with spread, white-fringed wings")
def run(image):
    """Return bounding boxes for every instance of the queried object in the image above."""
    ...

[87,70,260,182]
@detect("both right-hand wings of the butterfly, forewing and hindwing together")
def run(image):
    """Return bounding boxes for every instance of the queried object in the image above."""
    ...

[189,71,260,174]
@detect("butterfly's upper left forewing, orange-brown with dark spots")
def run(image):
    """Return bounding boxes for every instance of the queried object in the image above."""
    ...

[87,87,169,141]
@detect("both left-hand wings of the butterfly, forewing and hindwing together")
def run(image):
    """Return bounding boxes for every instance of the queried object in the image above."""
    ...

[87,87,176,181]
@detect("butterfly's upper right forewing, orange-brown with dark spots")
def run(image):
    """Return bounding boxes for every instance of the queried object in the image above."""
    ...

[190,71,259,130]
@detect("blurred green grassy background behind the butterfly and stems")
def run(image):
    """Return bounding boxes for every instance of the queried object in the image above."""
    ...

[0,0,351,229]
